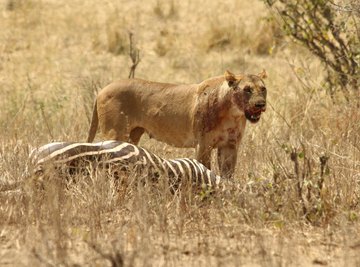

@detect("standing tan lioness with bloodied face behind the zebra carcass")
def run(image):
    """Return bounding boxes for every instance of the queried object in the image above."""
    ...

[88,71,266,178]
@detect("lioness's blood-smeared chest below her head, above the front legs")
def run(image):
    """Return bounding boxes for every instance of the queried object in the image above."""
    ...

[209,106,246,147]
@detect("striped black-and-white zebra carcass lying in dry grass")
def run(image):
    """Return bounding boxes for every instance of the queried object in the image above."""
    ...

[30,141,220,187]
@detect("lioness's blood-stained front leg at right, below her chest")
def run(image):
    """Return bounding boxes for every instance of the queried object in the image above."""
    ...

[217,144,237,179]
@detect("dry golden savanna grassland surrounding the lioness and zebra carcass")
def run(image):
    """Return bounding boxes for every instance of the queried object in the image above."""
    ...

[0,0,360,266]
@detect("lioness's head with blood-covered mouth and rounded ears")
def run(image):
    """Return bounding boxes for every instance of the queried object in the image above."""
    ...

[225,70,266,123]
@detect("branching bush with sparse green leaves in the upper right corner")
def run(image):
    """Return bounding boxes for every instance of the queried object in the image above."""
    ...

[265,0,360,101]
